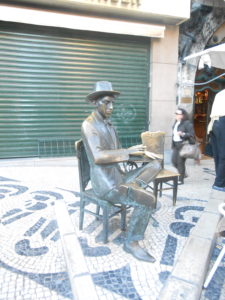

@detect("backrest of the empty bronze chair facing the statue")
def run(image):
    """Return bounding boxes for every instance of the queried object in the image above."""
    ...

[141,131,166,167]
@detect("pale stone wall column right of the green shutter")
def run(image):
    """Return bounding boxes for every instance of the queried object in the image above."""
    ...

[149,26,179,149]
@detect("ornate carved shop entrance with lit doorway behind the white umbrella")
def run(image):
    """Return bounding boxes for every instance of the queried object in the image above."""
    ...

[177,0,225,152]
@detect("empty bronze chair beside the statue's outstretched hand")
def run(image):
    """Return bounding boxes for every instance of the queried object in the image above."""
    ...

[141,131,180,209]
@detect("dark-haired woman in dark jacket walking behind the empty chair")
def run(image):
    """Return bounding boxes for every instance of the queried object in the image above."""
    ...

[172,108,195,184]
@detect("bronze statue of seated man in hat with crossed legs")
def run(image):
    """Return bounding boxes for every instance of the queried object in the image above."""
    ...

[81,81,161,262]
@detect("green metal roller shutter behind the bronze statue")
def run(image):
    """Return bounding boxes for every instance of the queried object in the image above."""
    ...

[0,23,149,158]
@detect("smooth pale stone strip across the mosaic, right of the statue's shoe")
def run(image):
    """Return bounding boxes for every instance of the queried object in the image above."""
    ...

[158,190,225,300]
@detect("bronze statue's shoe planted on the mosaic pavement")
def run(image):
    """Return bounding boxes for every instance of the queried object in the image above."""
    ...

[123,242,155,263]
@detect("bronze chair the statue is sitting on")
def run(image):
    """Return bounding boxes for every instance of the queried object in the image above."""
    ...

[75,140,127,243]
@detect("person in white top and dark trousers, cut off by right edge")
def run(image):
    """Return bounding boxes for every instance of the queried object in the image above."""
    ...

[207,89,225,192]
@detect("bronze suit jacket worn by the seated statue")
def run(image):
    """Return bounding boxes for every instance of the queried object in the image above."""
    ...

[81,111,129,197]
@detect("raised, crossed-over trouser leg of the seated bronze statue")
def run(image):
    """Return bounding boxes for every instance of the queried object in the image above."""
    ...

[125,160,162,186]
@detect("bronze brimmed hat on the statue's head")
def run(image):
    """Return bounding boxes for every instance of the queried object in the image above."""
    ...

[86,81,120,101]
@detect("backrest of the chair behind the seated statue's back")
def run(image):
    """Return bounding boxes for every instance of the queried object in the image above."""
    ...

[75,140,90,192]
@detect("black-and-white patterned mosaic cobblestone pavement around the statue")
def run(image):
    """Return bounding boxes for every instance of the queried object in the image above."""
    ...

[0,158,225,300]
